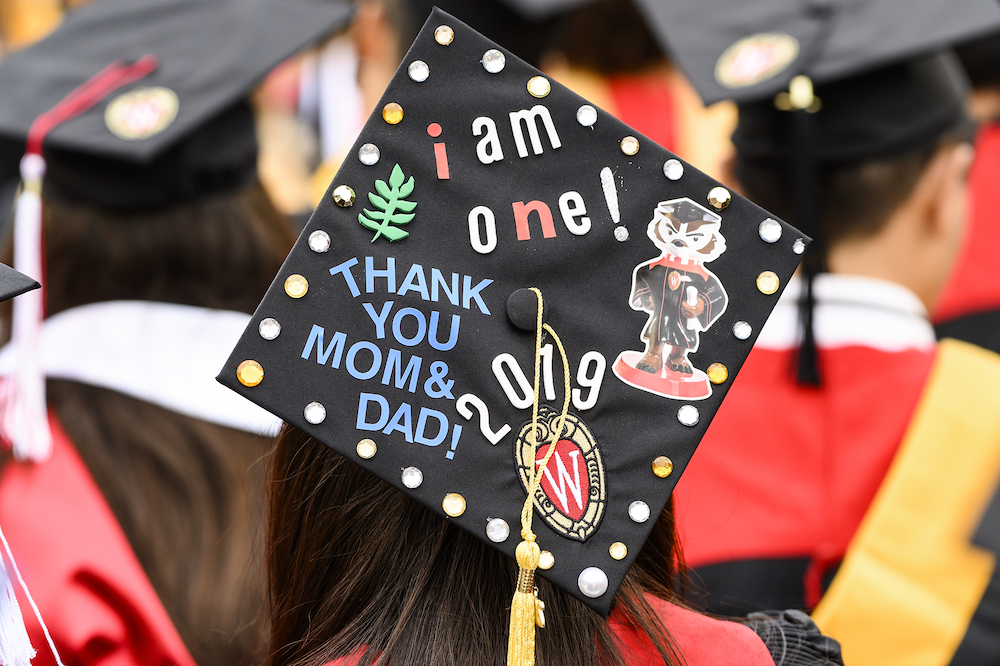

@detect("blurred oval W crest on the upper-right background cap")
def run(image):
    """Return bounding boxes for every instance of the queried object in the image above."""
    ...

[715,32,799,88]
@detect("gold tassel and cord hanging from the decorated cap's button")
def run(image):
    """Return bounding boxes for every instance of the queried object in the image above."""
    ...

[507,287,571,666]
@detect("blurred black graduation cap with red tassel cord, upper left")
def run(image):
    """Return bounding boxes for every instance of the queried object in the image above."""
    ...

[0,0,352,208]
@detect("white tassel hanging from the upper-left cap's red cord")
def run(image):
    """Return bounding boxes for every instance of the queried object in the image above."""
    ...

[0,153,52,462]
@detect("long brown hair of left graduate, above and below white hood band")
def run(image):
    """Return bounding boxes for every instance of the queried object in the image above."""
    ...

[7,184,293,666]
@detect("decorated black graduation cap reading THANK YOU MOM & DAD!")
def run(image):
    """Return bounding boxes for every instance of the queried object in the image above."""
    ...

[219,10,808,615]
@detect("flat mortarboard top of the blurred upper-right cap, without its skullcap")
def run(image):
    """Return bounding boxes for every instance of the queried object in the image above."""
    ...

[636,0,1000,104]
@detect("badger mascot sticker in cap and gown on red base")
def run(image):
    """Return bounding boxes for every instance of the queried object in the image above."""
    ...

[613,198,729,400]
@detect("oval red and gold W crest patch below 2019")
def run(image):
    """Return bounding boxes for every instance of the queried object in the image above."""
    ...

[514,405,607,541]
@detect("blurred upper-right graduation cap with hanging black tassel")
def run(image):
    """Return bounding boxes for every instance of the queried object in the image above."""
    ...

[637,0,1000,385]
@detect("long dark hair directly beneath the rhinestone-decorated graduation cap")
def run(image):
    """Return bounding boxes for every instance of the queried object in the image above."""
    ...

[267,426,682,666]
